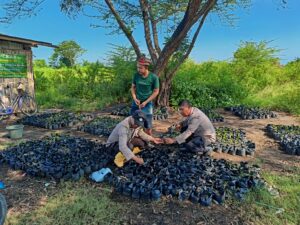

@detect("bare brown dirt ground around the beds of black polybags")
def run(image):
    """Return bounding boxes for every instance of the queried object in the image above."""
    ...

[0,110,300,225]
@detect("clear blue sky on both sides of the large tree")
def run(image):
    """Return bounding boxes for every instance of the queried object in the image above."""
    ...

[0,0,300,63]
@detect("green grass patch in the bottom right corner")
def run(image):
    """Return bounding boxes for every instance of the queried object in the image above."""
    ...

[241,168,300,225]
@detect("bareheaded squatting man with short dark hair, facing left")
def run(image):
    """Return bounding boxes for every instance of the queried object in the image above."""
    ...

[164,100,216,154]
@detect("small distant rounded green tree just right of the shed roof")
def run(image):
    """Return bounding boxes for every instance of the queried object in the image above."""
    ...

[49,40,85,67]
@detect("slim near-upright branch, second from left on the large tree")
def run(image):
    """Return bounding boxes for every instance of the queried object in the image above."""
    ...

[140,0,158,64]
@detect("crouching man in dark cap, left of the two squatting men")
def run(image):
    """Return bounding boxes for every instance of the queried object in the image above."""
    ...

[106,110,163,164]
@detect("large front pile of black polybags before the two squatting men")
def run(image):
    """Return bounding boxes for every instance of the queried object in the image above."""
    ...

[108,146,262,206]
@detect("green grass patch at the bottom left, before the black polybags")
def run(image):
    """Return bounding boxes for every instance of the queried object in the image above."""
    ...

[5,182,122,225]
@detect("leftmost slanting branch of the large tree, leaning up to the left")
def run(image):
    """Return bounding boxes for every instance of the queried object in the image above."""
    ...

[105,0,142,57]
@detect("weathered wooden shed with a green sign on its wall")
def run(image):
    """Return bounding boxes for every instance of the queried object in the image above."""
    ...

[0,34,57,100]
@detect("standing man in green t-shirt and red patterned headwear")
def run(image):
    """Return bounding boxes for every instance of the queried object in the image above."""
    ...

[130,57,159,135]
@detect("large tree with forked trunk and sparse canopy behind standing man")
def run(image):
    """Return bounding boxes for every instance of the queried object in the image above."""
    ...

[2,0,285,105]
